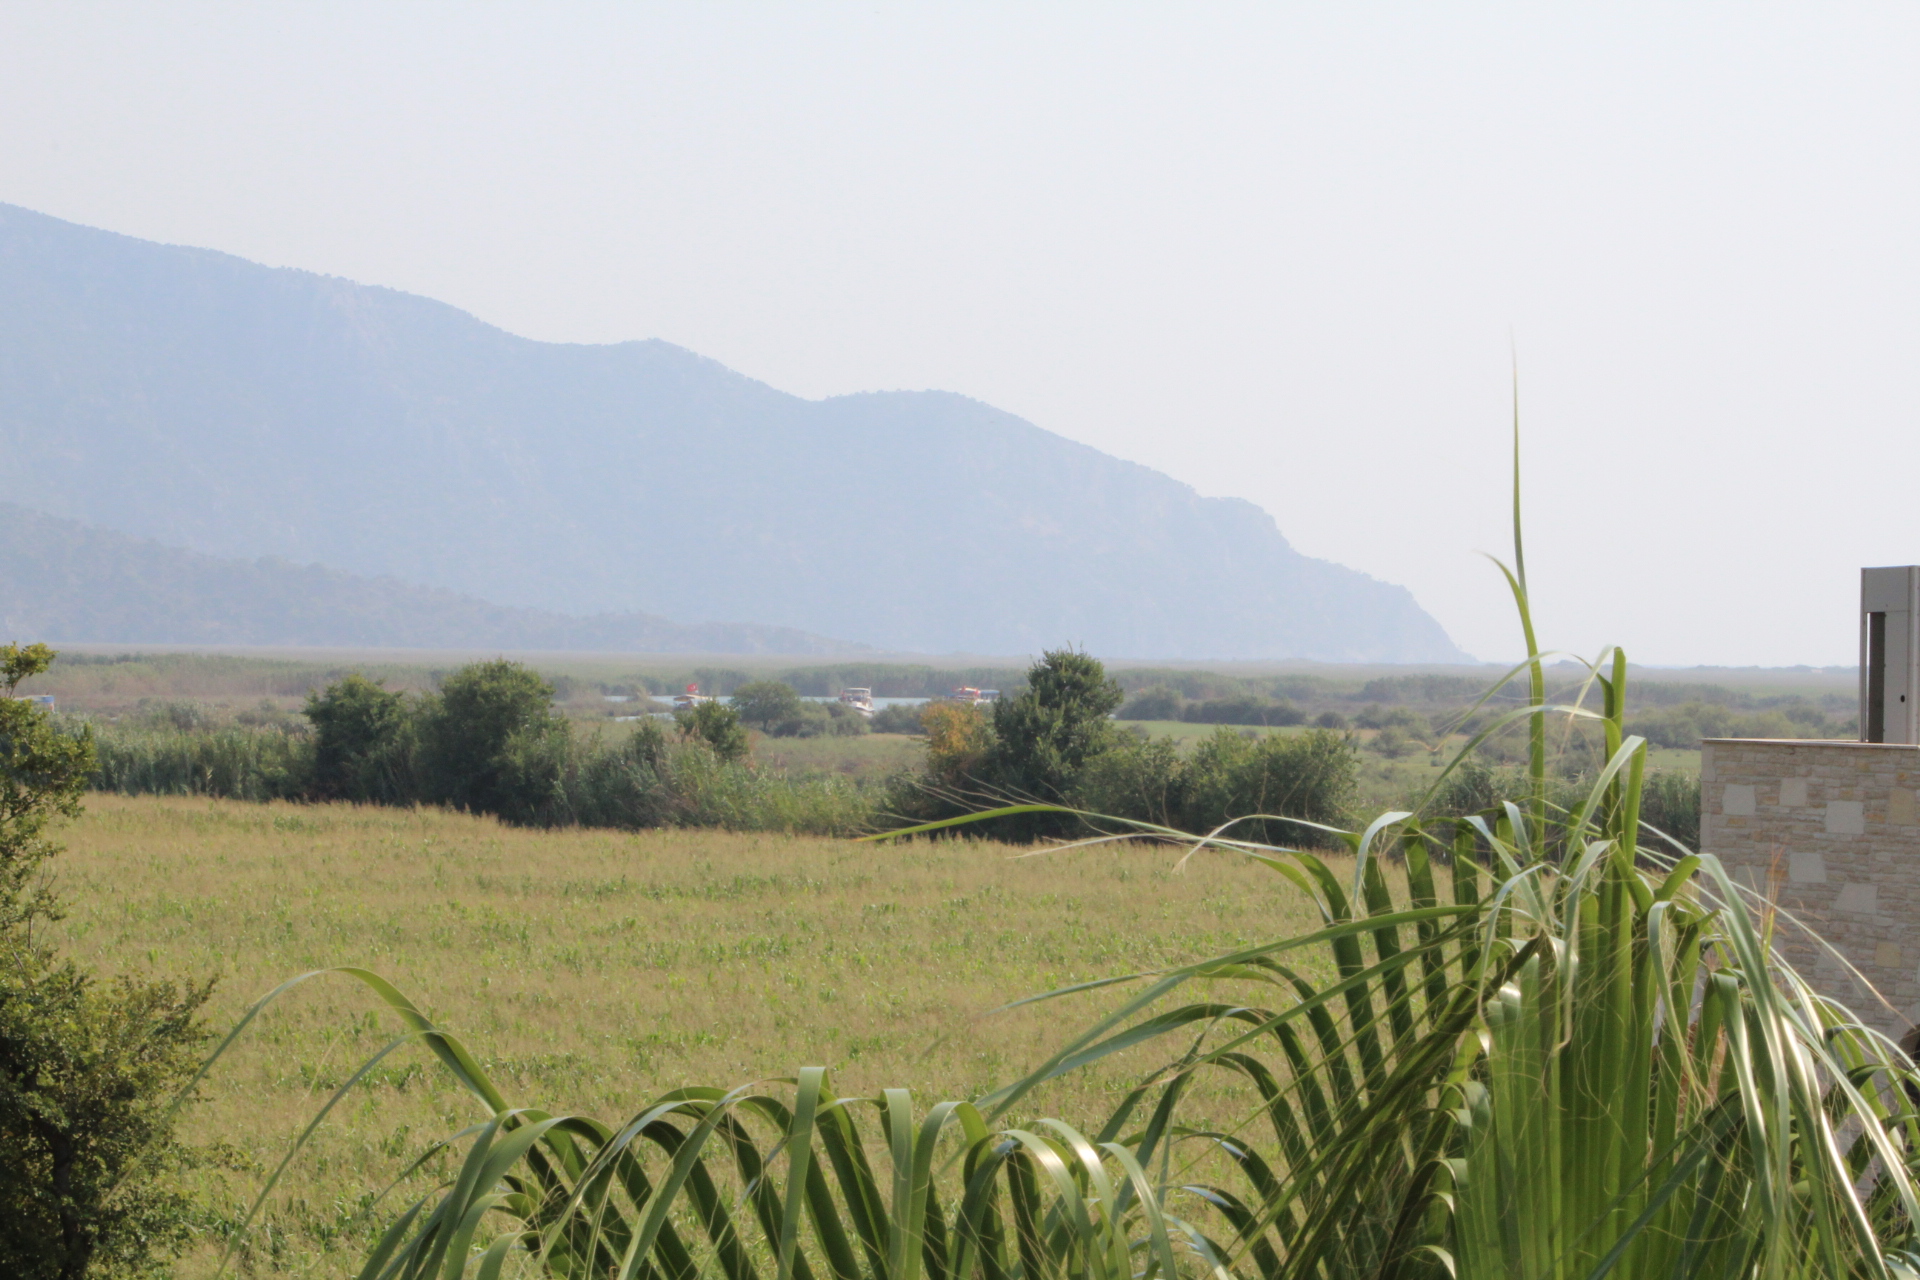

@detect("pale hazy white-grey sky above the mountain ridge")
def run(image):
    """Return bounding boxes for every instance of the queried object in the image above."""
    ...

[0,0,1920,664]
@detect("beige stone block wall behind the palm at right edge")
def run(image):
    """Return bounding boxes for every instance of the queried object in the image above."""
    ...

[1699,739,1920,1036]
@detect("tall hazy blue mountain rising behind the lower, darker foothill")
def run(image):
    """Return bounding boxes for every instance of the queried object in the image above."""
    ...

[0,205,1463,662]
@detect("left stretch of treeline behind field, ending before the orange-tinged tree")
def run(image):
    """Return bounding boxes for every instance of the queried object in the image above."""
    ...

[94,660,877,835]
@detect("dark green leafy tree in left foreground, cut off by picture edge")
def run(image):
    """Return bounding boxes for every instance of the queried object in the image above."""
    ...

[0,645,211,1280]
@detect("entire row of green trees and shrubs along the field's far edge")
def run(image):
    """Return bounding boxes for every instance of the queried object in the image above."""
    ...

[74,651,1704,842]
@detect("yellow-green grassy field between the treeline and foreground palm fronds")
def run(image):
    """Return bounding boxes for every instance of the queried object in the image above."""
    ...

[58,796,1351,1276]
